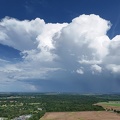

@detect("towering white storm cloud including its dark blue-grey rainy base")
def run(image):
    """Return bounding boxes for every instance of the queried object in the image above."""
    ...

[0,14,120,92]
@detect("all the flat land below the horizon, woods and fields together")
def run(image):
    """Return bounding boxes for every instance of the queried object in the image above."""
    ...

[0,93,120,120]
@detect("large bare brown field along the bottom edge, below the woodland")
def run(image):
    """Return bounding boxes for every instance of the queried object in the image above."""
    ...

[40,111,120,120]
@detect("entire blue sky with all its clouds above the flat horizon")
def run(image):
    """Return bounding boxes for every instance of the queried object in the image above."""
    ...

[0,0,120,94]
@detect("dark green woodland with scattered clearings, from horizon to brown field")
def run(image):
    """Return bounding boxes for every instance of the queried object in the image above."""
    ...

[0,93,120,120]
